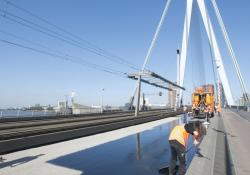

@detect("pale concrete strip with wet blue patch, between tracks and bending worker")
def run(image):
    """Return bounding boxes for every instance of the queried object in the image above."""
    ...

[0,117,184,175]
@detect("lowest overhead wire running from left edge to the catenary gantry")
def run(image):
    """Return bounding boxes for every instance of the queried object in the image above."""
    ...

[0,39,127,77]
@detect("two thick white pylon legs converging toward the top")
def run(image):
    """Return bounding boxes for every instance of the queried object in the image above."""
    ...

[177,0,234,105]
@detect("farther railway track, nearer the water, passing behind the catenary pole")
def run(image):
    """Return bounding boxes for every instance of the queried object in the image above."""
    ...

[0,111,171,140]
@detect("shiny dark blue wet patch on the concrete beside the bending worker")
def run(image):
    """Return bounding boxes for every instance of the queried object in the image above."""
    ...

[49,114,195,175]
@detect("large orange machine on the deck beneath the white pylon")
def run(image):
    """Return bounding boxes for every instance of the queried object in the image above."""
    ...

[192,84,215,117]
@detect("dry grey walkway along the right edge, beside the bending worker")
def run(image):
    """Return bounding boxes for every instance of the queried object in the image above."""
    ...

[187,110,250,175]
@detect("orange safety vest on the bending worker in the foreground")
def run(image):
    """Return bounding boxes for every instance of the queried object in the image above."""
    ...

[168,125,189,147]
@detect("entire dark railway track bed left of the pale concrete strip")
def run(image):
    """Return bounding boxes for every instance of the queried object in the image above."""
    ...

[0,110,182,154]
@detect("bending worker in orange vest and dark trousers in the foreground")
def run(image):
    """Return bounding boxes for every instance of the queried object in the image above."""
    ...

[169,122,201,175]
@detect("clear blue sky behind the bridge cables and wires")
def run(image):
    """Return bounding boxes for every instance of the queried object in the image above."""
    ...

[0,0,250,107]
